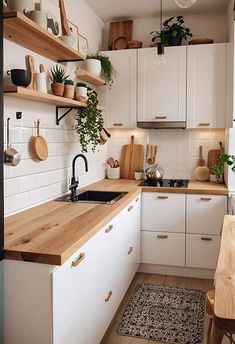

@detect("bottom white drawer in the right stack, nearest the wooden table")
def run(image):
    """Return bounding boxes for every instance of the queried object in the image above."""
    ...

[186,234,220,269]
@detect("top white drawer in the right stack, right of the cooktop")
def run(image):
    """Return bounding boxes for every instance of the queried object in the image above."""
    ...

[186,195,227,235]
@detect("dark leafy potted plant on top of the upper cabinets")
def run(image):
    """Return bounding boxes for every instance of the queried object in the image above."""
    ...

[151,16,193,46]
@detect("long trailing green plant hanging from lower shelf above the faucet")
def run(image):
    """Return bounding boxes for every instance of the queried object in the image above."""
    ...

[75,87,104,153]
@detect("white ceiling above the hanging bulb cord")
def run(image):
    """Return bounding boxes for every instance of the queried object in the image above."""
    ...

[86,0,229,22]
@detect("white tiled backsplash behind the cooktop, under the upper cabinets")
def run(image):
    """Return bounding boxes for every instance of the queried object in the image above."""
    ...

[108,129,224,179]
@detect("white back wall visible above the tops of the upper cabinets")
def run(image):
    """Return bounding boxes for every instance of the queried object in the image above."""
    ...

[103,14,227,50]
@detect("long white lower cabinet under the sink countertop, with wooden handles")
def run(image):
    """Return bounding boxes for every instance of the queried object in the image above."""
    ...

[5,196,141,344]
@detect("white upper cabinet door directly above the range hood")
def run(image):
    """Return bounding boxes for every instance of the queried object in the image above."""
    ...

[138,46,186,121]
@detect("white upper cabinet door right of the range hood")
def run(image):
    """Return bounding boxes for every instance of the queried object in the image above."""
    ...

[187,43,226,128]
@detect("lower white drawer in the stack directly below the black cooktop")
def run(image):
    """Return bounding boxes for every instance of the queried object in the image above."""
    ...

[141,231,185,266]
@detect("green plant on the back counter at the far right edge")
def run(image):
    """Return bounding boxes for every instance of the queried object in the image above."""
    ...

[210,153,235,183]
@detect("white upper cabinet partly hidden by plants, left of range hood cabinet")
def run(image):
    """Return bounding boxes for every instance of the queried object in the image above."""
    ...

[99,49,137,128]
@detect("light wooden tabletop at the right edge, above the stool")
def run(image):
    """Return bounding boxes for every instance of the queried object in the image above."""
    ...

[214,215,235,320]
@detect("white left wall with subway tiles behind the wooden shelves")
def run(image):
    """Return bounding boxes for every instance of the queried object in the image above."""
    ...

[4,0,107,215]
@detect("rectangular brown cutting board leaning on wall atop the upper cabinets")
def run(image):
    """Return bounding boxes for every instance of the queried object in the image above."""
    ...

[109,20,133,49]
